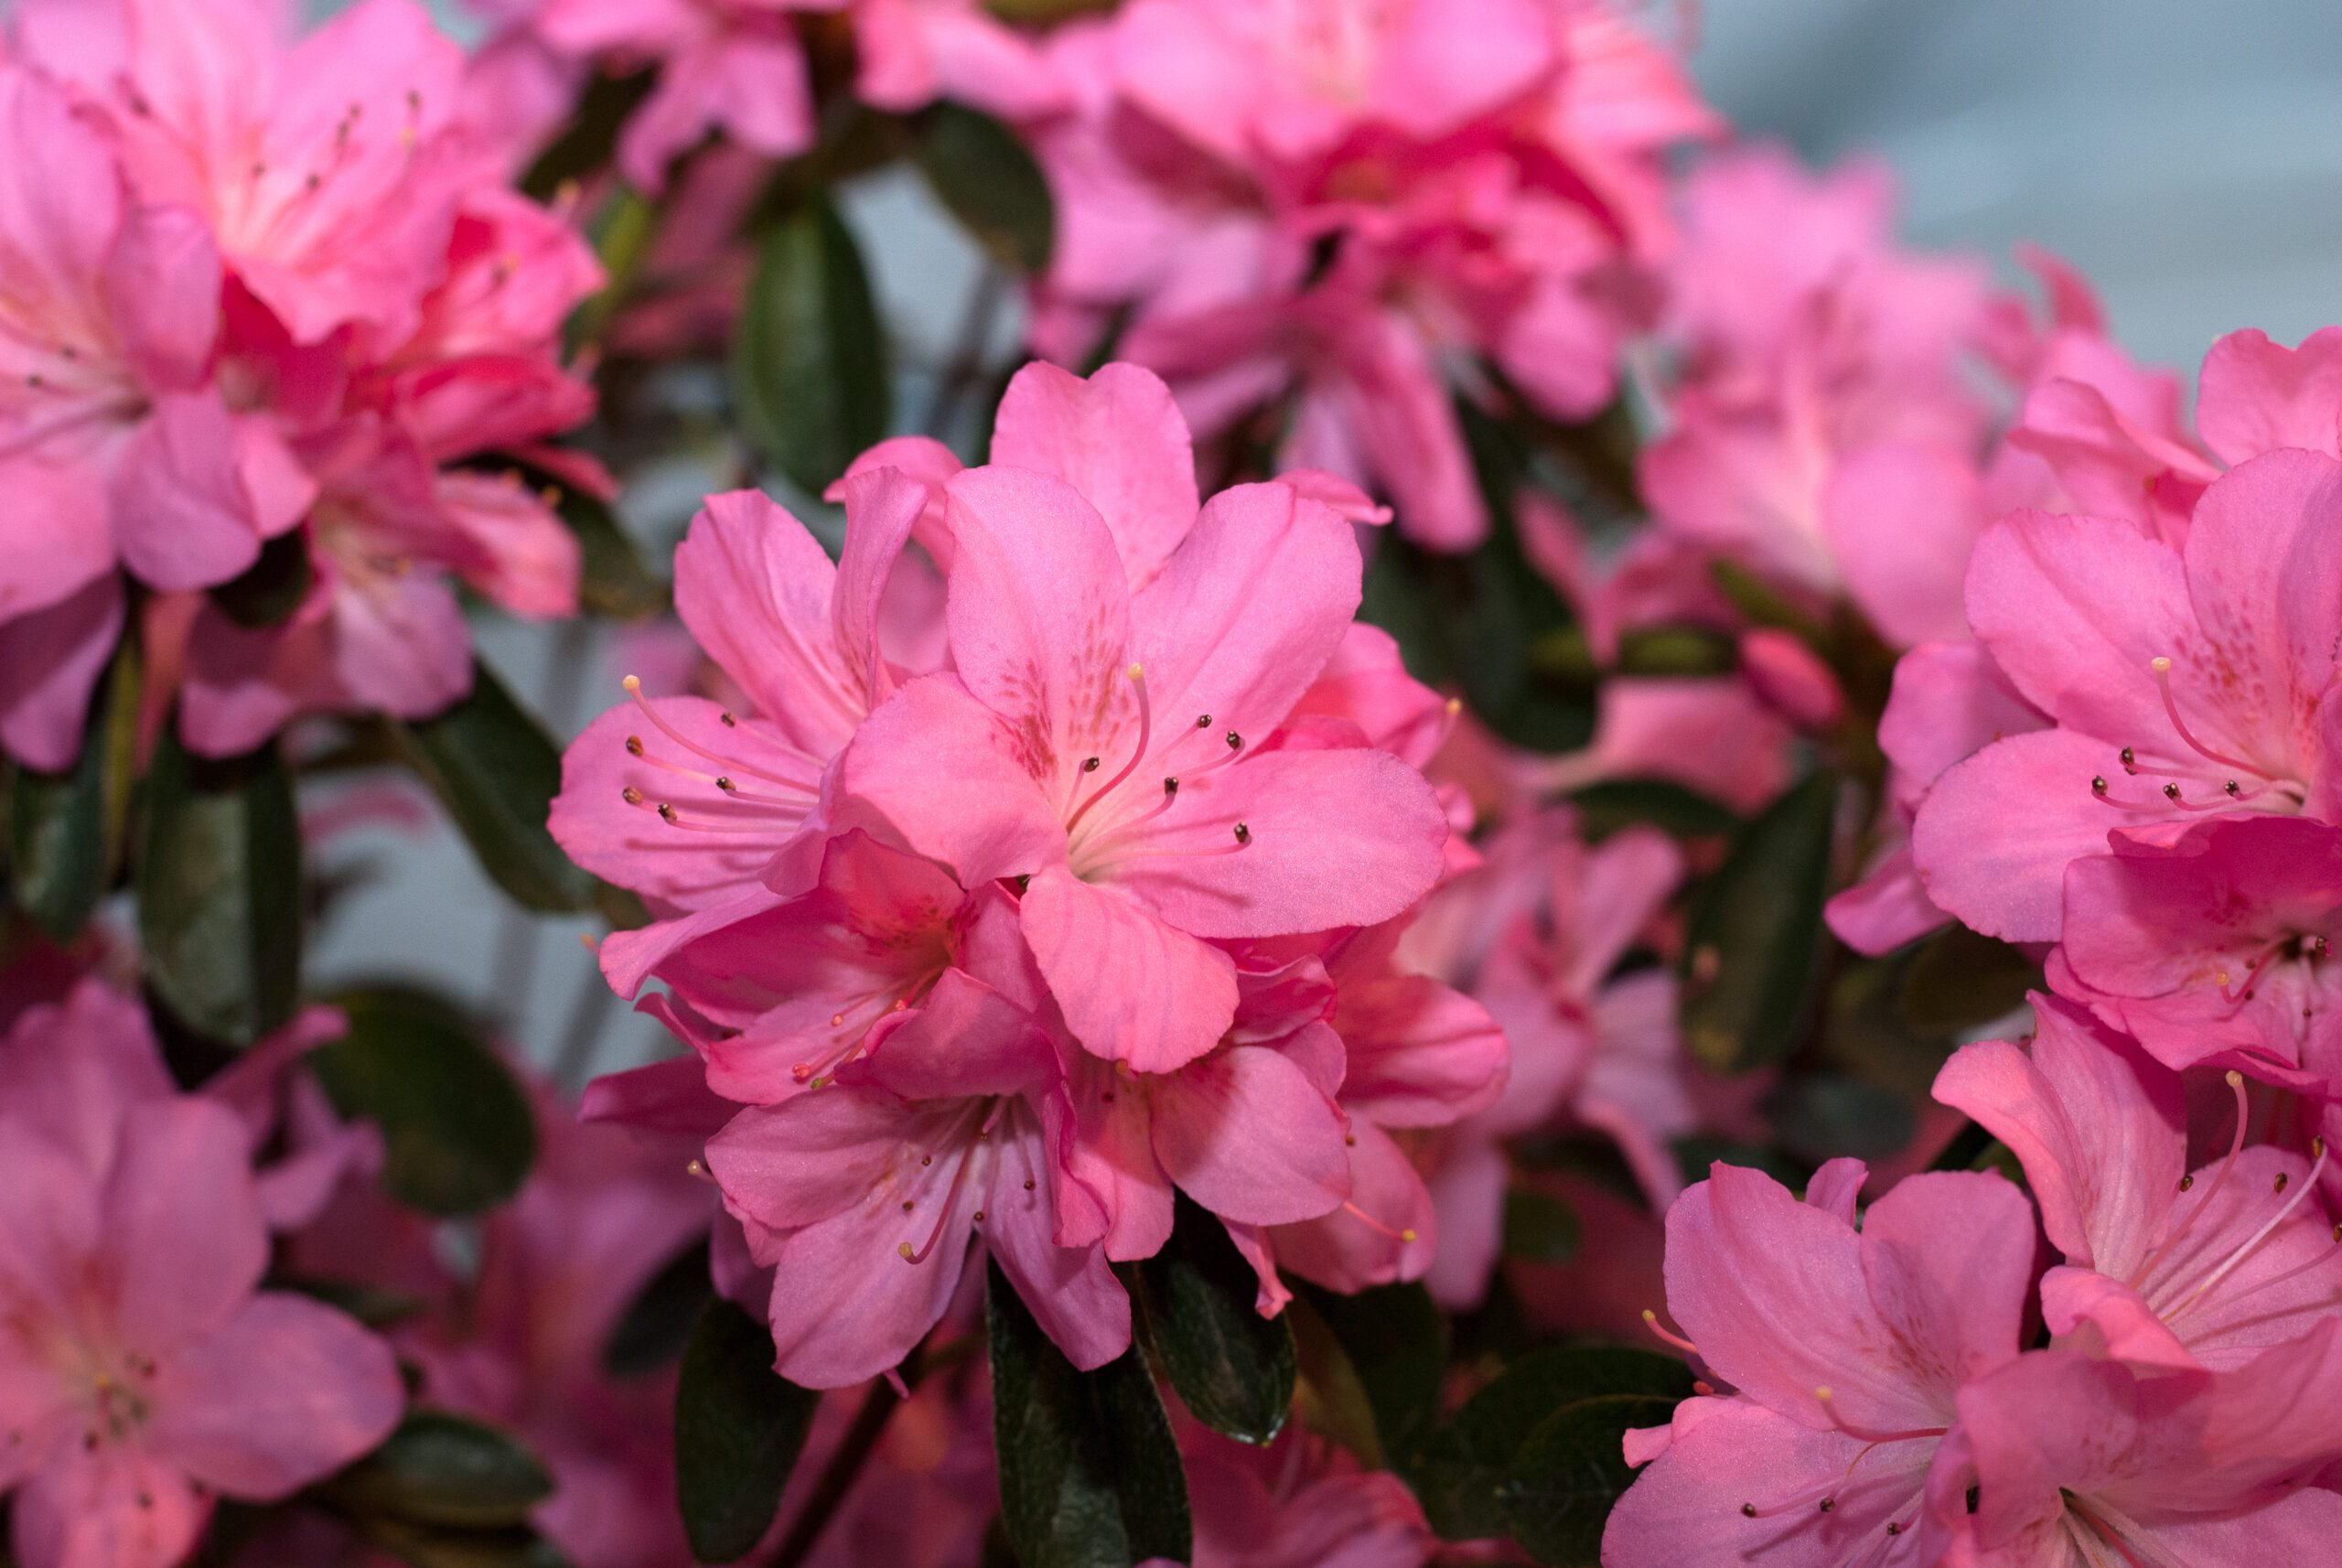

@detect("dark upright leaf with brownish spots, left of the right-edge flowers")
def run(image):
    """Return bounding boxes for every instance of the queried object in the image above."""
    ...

[1684,772,1839,1072]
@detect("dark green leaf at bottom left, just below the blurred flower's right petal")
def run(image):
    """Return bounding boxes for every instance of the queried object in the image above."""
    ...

[321,1409,553,1530]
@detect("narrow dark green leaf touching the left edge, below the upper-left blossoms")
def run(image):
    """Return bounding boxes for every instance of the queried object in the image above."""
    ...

[7,641,138,943]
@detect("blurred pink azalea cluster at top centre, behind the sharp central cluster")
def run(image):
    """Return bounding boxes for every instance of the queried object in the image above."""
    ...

[1033,0,1722,550]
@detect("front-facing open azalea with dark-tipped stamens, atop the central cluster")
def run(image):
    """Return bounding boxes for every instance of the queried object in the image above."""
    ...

[829,370,1447,1072]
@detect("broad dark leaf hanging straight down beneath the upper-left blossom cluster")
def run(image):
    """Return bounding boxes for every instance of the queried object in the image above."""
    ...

[135,730,302,1047]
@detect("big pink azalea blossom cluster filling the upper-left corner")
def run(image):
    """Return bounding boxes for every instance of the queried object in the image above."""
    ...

[0,0,607,770]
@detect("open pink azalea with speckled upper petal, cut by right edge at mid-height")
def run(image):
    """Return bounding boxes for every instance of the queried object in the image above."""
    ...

[1911,452,2342,940]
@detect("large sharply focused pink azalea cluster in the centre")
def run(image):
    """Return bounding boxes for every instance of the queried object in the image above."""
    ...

[553,365,1504,1388]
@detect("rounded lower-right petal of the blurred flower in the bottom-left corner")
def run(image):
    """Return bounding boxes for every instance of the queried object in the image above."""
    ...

[147,1292,405,1500]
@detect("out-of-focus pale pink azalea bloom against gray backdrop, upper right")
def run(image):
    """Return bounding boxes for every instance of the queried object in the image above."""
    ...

[1642,150,1988,644]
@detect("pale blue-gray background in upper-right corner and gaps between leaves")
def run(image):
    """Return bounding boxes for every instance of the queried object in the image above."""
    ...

[314,0,2342,1068]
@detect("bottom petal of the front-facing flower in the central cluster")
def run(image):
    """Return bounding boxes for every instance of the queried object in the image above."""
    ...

[1019,856,1237,1072]
